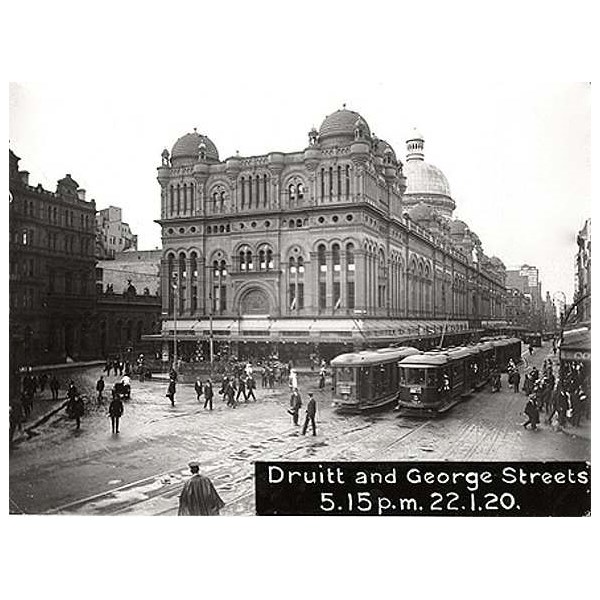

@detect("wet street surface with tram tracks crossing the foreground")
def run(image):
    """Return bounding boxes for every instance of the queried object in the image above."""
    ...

[10,346,590,515]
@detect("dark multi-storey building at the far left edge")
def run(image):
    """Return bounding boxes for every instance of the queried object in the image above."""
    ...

[9,149,96,366]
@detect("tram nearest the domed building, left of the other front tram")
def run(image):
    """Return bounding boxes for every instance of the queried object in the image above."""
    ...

[330,346,421,412]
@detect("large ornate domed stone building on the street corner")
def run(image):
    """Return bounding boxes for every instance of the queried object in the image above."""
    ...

[158,108,505,356]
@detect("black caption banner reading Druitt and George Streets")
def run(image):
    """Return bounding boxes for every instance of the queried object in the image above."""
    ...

[255,462,591,517]
